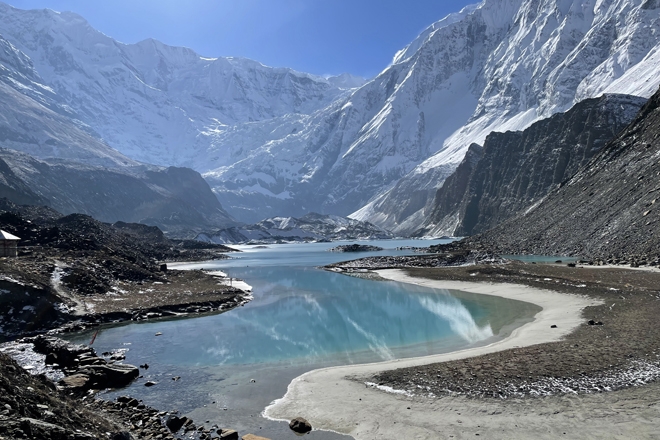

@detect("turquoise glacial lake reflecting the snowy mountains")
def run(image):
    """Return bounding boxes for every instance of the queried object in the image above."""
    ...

[68,240,540,440]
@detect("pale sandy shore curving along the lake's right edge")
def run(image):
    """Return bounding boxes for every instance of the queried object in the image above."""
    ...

[265,270,608,440]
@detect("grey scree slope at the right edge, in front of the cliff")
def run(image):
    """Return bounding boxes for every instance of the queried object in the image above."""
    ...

[468,84,660,262]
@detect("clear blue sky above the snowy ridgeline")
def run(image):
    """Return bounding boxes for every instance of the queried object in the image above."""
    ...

[9,0,476,77]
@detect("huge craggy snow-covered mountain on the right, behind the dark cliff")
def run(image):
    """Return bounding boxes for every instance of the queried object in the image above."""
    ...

[205,0,660,223]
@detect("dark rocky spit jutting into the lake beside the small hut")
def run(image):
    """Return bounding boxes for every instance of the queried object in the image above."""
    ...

[0,199,242,341]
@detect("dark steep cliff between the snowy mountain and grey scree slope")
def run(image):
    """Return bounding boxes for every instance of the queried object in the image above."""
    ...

[422,95,644,236]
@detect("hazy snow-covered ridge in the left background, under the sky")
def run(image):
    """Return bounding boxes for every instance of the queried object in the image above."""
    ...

[0,3,363,171]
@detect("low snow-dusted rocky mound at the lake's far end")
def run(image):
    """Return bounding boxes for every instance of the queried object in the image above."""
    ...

[197,212,393,244]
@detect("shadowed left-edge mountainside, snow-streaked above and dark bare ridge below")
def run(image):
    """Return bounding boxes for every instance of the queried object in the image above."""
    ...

[0,32,236,236]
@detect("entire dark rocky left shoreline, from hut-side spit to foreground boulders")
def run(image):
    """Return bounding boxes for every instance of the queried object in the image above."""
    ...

[0,200,270,440]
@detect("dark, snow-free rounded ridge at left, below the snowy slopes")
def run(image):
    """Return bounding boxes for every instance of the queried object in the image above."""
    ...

[0,149,236,238]
